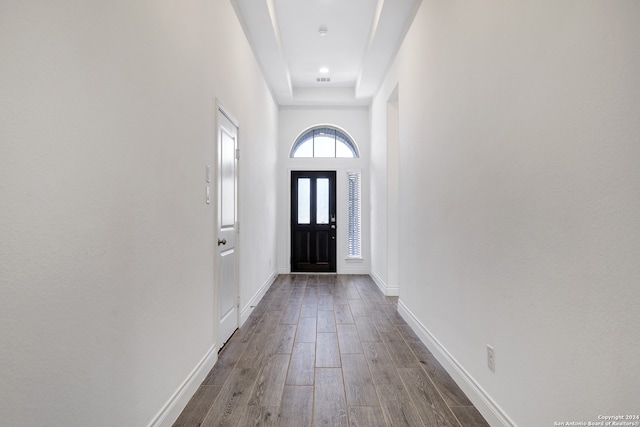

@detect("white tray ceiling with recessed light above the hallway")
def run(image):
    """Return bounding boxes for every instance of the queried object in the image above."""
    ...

[231,0,421,106]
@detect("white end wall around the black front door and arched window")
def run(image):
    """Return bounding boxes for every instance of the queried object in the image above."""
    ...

[278,107,371,274]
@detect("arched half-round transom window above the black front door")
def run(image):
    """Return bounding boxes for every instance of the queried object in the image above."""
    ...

[291,126,360,158]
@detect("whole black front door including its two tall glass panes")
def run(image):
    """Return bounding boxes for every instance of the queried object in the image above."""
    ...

[291,171,337,273]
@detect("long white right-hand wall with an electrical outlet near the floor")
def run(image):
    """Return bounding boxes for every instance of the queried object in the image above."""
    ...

[372,0,640,426]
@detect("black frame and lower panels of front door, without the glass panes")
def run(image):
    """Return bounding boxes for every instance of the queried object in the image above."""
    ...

[290,170,337,273]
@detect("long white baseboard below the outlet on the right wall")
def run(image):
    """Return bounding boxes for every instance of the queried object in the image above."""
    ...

[400,300,516,427]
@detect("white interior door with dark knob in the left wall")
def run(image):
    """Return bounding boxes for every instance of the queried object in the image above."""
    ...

[217,109,239,347]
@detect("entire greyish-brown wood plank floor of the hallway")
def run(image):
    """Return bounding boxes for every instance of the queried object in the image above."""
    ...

[174,275,487,427]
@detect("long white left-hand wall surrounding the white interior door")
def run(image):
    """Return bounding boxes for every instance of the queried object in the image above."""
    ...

[0,0,278,426]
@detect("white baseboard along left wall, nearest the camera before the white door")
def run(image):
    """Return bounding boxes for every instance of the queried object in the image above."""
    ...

[148,344,218,427]
